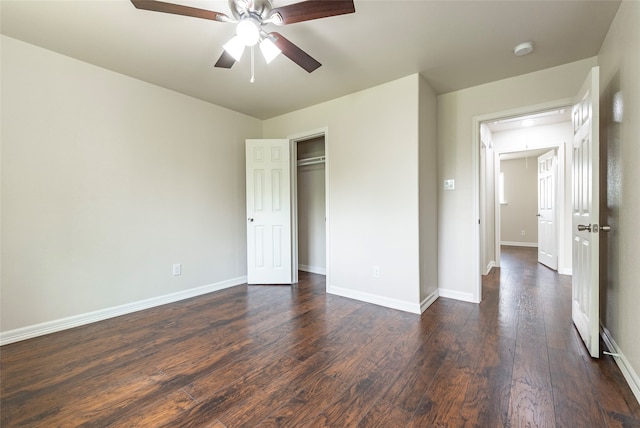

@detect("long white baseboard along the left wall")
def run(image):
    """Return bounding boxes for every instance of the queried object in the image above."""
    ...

[0,276,247,346]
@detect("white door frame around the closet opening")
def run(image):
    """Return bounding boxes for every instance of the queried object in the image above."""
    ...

[287,126,331,287]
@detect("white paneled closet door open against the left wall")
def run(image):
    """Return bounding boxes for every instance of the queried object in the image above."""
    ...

[246,140,292,284]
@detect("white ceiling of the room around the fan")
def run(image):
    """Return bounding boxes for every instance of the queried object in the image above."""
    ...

[0,0,619,119]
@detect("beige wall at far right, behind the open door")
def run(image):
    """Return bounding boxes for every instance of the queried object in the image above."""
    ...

[598,1,640,400]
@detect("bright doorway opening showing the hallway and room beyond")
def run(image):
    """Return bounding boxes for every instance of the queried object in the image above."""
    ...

[478,105,572,275]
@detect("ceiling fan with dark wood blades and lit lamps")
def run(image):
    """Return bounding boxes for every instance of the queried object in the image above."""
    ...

[131,0,356,73]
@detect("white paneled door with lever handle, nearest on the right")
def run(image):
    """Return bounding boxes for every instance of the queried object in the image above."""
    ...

[571,67,600,358]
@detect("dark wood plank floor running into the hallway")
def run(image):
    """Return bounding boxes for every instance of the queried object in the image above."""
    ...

[0,247,640,427]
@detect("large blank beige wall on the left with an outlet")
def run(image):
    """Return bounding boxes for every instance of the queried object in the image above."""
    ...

[0,36,262,332]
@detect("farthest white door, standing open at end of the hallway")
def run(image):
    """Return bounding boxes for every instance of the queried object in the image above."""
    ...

[538,150,558,270]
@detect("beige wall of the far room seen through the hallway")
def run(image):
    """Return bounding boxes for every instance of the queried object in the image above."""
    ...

[500,157,538,246]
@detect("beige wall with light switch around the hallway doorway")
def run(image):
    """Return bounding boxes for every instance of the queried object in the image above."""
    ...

[438,58,596,301]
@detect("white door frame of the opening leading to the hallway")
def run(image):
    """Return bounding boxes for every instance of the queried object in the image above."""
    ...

[471,98,574,303]
